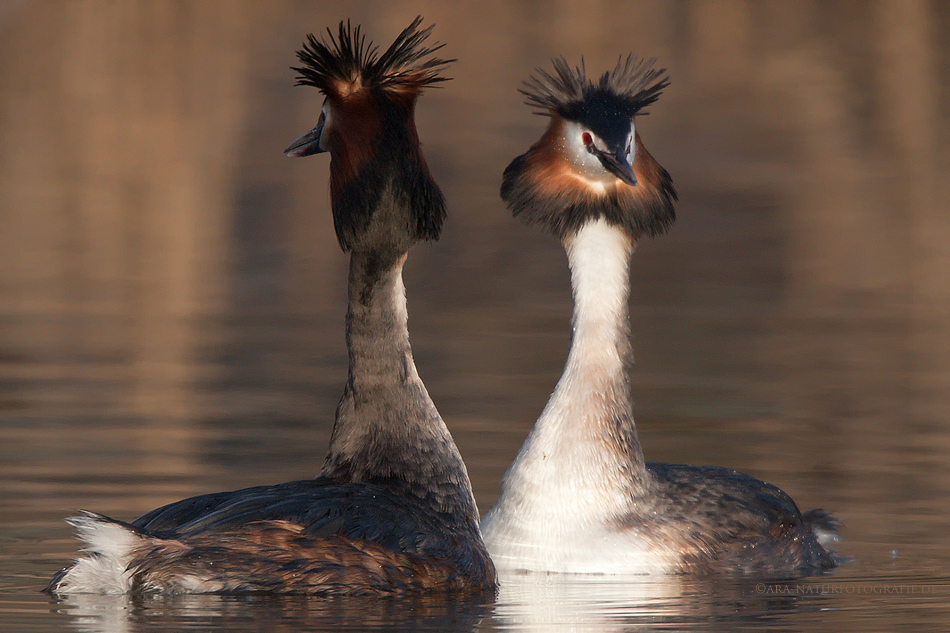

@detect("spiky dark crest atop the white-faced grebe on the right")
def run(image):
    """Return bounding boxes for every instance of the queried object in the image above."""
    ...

[520,55,670,121]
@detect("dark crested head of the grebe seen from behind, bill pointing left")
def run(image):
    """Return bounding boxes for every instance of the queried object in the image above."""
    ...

[285,17,454,251]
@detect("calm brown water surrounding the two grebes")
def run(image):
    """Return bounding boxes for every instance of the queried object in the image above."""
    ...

[0,0,950,633]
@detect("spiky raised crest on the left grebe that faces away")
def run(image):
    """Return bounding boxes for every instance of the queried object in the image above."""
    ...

[294,16,455,98]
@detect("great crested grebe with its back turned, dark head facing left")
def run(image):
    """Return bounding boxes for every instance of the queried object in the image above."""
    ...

[48,18,495,594]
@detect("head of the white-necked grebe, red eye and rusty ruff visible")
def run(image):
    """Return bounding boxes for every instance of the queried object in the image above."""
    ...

[501,56,676,239]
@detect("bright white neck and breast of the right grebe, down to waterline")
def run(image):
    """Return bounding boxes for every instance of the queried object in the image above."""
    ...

[482,220,668,573]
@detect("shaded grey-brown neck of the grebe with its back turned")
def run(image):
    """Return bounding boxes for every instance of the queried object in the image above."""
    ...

[321,244,478,522]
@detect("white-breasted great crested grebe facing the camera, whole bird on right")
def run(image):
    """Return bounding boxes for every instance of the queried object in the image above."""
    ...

[482,56,837,575]
